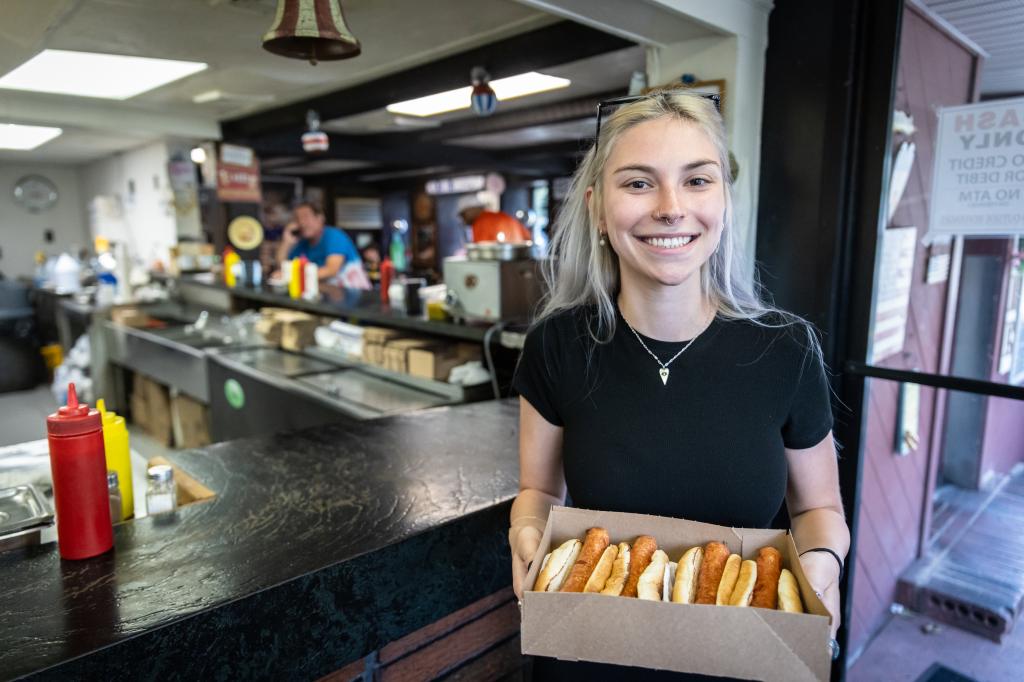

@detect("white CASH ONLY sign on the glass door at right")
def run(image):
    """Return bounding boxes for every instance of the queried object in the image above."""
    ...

[928,97,1024,240]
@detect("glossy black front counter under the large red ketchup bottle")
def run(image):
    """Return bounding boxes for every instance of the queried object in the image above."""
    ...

[0,400,518,679]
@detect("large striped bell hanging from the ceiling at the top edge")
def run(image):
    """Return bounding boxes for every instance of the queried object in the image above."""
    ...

[263,0,360,65]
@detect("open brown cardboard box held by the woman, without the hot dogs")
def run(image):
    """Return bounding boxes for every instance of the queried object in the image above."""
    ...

[521,507,831,682]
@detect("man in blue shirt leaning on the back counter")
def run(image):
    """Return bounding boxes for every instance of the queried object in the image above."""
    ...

[278,202,362,282]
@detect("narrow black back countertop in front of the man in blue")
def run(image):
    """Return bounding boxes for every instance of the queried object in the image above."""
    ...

[177,275,489,342]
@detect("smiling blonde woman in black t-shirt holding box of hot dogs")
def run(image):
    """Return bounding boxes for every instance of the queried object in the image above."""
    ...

[509,90,850,680]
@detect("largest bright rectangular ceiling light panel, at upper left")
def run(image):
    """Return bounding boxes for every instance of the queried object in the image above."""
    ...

[0,50,207,99]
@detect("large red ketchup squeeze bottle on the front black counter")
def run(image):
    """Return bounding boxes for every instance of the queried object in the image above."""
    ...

[46,384,114,559]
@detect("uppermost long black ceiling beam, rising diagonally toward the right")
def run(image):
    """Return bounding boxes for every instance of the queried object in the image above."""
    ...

[221,22,634,143]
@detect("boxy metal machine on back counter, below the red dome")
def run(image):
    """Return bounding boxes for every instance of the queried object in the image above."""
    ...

[444,254,544,322]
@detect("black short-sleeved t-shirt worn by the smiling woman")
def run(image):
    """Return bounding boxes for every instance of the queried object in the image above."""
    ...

[514,308,833,527]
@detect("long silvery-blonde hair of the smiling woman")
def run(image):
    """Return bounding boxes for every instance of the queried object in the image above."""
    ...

[538,89,821,363]
